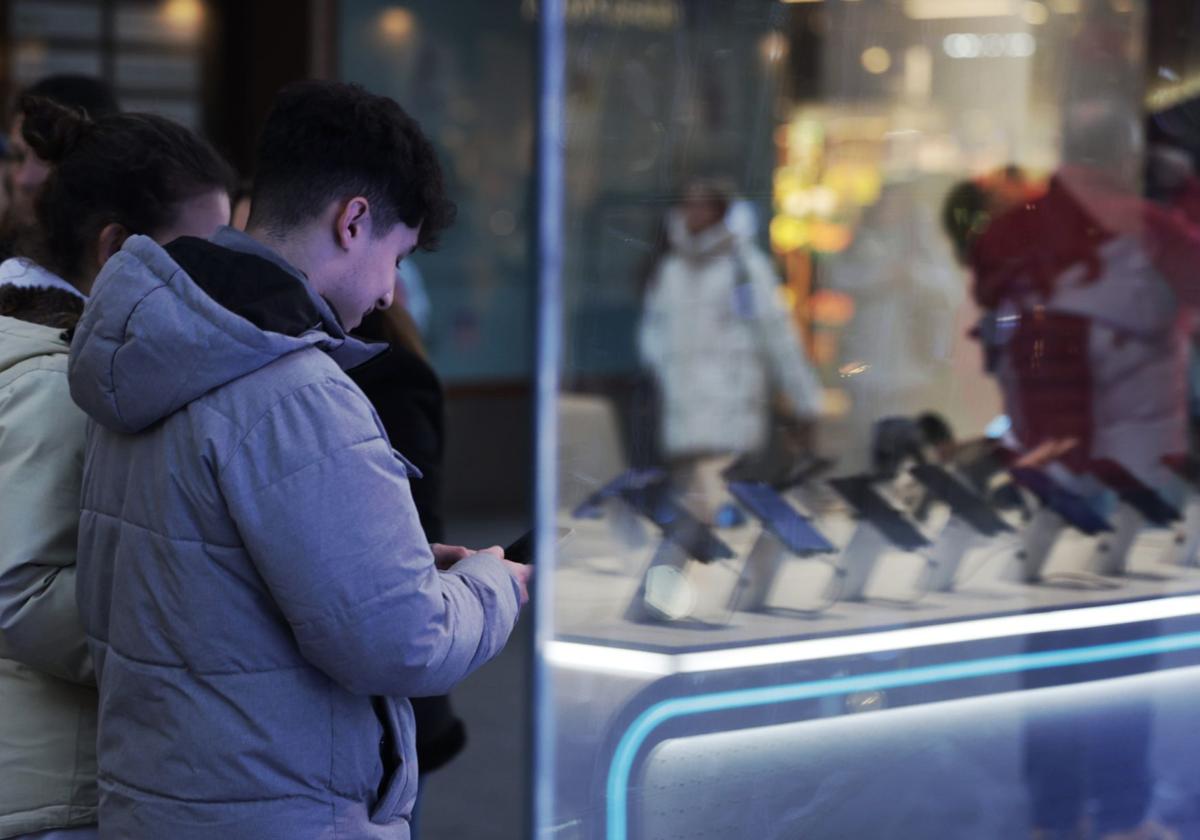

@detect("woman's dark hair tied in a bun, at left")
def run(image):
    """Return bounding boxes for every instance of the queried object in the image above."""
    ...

[18,96,234,281]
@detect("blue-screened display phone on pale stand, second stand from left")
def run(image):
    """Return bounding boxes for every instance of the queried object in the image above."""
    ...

[728,481,836,613]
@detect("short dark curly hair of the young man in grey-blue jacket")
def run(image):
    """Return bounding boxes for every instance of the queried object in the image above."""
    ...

[250,80,455,251]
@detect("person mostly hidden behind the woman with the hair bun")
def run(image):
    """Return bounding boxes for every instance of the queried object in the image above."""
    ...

[0,74,120,257]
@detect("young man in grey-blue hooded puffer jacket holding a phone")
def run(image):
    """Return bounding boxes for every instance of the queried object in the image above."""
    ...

[70,82,528,840]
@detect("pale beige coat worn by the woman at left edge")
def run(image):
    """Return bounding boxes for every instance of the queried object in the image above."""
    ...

[0,287,96,838]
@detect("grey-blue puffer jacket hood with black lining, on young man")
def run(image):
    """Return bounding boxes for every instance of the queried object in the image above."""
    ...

[68,236,380,433]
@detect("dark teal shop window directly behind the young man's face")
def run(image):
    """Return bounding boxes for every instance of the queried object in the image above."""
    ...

[338,0,536,384]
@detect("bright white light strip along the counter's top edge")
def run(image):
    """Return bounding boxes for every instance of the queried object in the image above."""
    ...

[545,595,1200,677]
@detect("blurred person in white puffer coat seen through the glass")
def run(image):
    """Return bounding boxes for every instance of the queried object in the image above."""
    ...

[637,180,822,523]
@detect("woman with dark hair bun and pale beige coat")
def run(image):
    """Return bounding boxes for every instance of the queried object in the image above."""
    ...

[0,96,230,840]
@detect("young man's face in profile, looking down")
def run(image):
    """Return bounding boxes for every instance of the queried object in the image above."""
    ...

[323,216,421,330]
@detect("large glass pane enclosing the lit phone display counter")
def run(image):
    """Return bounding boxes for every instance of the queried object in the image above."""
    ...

[537,0,1200,840]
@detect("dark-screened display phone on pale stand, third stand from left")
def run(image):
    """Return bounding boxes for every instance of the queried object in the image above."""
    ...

[829,475,929,601]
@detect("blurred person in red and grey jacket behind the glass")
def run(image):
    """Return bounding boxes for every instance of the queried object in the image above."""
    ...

[970,103,1200,486]
